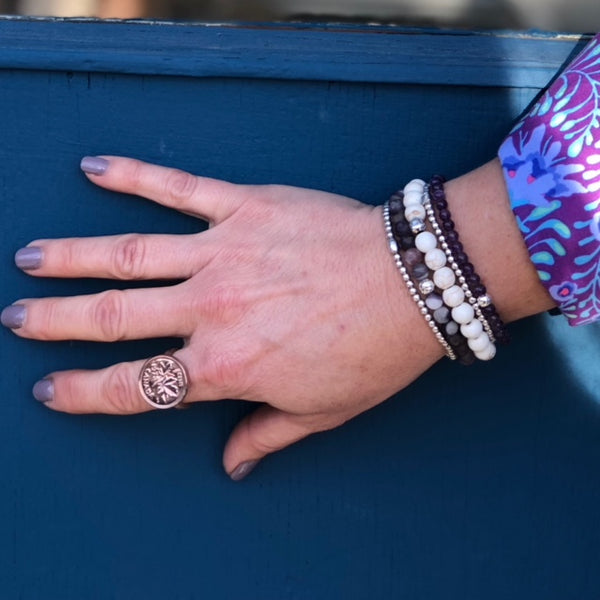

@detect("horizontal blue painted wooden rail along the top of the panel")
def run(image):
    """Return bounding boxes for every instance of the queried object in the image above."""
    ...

[0,18,588,87]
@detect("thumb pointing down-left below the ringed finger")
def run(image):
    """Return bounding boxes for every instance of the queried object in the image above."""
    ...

[223,404,313,481]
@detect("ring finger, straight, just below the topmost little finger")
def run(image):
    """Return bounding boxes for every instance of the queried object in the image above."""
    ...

[15,232,210,280]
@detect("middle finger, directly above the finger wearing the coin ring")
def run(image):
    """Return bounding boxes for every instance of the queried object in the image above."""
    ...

[2,286,194,342]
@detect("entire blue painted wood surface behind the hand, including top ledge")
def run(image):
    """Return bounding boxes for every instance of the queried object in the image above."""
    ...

[0,20,600,600]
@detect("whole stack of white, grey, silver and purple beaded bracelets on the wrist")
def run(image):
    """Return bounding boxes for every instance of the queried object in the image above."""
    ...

[383,177,505,364]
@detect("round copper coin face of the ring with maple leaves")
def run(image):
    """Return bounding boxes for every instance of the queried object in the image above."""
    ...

[138,354,188,408]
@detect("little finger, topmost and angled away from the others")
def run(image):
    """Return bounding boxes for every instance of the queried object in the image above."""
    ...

[81,156,244,223]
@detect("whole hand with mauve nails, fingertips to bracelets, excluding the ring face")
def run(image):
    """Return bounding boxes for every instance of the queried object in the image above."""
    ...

[3,157,443,479]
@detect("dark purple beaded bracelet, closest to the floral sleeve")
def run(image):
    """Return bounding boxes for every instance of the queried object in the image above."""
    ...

[428,175,510,344]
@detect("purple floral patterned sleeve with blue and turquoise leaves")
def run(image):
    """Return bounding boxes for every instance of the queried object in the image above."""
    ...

[499,34,600,325]
